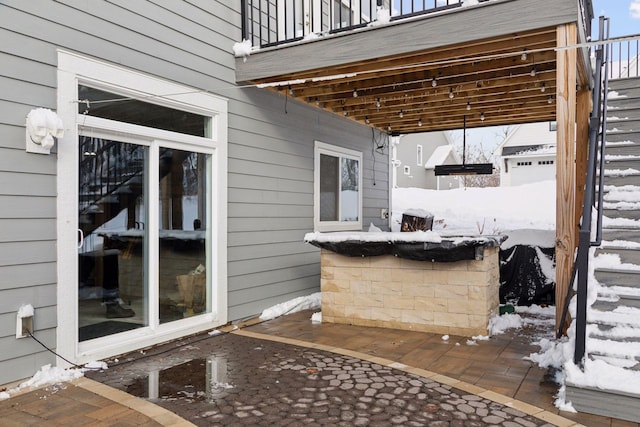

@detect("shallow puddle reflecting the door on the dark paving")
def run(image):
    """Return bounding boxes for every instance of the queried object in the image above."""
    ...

[126,356,233,402]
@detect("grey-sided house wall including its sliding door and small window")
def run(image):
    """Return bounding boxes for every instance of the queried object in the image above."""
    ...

[0,0,389,384]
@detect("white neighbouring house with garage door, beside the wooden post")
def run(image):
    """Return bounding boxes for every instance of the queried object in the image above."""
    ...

[495,122,556,187]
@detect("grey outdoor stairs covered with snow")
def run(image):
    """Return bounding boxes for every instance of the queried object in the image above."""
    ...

[566,78,640,422]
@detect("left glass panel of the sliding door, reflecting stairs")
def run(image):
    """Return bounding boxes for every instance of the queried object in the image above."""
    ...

[78,136,149,341]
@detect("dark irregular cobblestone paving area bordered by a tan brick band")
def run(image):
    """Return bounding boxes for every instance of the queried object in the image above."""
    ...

[87,334,550,427]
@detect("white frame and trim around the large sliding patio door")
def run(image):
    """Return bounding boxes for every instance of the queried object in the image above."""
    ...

[56,50,228,365]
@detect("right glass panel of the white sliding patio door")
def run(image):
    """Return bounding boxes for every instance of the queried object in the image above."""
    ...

[158,148,211,323]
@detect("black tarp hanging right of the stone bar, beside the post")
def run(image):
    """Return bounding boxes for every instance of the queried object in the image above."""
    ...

[500,245,556,306]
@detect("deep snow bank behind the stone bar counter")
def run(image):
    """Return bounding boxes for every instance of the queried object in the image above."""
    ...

[391,181,556,236]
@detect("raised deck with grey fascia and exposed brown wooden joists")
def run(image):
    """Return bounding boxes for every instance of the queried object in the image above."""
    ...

[236,0,590,134]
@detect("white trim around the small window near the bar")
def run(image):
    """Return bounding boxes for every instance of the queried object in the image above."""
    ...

[313,141,364,232]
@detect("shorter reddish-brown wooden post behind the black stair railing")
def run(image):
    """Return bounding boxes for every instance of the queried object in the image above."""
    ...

[575,87,593,234]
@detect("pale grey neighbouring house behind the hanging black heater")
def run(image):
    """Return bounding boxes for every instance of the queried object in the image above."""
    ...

[392,131,461,190]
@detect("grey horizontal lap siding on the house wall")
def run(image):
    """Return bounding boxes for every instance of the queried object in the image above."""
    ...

[0,0,389,384]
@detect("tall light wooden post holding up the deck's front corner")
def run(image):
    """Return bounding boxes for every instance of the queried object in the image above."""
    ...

[556,24,578,334]
